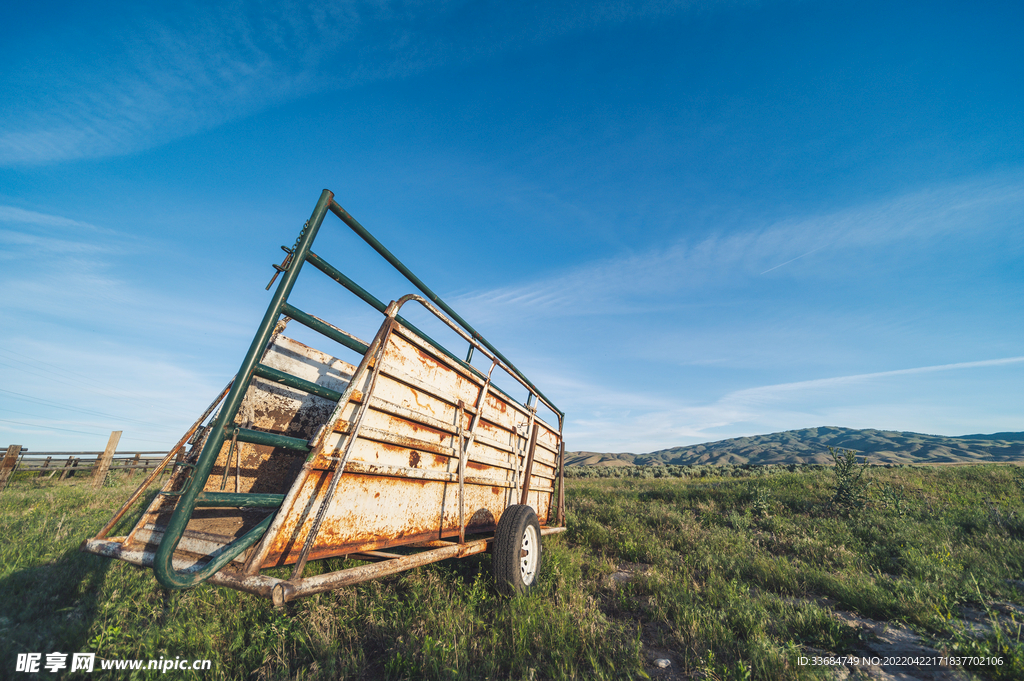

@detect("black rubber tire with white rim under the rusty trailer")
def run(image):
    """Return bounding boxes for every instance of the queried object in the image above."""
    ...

[492,504,543,596]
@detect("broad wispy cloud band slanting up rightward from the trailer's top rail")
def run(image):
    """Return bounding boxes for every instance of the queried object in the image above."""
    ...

[454,177,1024,318]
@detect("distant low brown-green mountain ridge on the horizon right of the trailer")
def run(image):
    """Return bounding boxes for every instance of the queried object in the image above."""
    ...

[565,426,1024,466]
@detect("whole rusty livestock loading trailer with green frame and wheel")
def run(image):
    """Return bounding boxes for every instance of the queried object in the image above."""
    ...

[82,189,564,606]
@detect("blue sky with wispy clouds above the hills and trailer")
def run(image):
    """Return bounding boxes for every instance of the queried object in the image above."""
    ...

[0,0,1024,453]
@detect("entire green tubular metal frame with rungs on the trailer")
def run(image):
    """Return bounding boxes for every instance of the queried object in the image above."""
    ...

[153,189,564,589]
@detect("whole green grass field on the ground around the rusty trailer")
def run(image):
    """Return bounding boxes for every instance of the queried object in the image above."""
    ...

[0,458,1024,680]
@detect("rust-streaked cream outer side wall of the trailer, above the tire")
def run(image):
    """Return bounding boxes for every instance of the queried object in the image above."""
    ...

[262,324,559,566]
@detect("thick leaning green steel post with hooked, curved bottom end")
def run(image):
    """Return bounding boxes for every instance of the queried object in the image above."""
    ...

[153,189,334,589]
